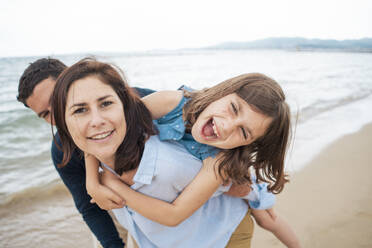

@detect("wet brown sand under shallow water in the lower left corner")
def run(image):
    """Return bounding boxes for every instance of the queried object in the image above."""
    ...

[0,186,92,248]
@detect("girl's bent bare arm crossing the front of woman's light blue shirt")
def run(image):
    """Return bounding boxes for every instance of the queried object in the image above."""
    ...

[102,158,222,226]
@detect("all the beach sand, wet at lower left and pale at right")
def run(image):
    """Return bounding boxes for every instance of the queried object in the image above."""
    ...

[0,124,372,248]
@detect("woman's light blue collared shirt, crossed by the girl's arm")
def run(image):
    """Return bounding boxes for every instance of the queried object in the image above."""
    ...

[113,136,248,248]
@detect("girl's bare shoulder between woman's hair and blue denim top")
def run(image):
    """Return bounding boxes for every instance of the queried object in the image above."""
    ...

[141,90,183,120]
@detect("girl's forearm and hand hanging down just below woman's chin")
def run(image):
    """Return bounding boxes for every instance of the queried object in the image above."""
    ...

[84,153,125,210]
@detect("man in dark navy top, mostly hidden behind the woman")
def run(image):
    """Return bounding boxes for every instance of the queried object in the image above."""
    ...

[17,58,153,248]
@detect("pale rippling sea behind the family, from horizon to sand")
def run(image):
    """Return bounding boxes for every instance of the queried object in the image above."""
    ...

[0,49,372,246]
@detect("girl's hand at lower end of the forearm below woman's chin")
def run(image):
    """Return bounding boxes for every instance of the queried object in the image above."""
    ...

[88,180,125,210]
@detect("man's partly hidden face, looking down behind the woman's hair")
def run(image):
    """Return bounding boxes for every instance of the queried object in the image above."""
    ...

[26,77,56,125]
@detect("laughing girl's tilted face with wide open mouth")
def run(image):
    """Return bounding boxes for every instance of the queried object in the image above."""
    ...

[191,93,272,149]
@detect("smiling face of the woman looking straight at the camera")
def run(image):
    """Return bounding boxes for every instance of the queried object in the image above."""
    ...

[65,76,127,161]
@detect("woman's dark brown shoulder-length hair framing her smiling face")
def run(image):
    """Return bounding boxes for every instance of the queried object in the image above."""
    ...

[51,58,155,175]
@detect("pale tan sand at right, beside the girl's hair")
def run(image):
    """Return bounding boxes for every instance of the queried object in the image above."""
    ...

[252,123,372,248]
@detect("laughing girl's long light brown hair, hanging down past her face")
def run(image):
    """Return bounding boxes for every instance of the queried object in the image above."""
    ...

[184,73,291,193]
